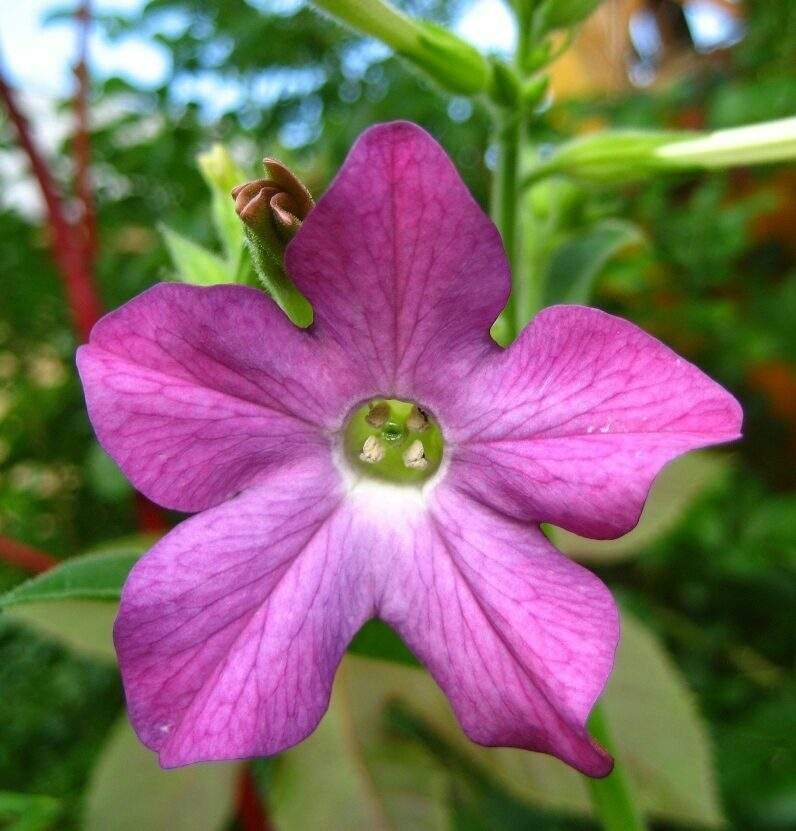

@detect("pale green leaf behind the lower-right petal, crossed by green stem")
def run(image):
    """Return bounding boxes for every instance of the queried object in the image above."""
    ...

[336,613,722,827]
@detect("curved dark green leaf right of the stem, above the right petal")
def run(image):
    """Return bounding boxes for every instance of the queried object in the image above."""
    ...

[543,219,644,306]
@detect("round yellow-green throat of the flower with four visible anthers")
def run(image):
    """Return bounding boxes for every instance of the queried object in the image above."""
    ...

[344,398,443,484]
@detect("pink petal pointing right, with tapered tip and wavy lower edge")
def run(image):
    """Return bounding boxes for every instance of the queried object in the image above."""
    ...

[449,306,743,539]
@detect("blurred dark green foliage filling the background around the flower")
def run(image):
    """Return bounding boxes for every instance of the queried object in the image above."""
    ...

[0,0,796,829]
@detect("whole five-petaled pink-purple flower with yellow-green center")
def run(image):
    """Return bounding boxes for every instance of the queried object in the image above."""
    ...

[78,123,741,776]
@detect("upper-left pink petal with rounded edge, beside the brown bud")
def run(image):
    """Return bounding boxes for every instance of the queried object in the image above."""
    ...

[77,284,346,511]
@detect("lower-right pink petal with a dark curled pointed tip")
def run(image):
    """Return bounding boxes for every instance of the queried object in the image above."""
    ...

[379,488,619,776]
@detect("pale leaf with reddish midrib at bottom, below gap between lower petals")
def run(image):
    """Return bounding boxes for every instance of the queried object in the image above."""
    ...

[269,658,450,831]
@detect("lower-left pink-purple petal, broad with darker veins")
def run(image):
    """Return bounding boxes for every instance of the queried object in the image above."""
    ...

[114,464,373,767]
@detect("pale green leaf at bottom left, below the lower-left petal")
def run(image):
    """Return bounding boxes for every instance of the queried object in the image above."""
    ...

[82,717,240,831]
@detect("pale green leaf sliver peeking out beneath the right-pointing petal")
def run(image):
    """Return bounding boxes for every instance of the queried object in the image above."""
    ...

[547,450,730,563]
